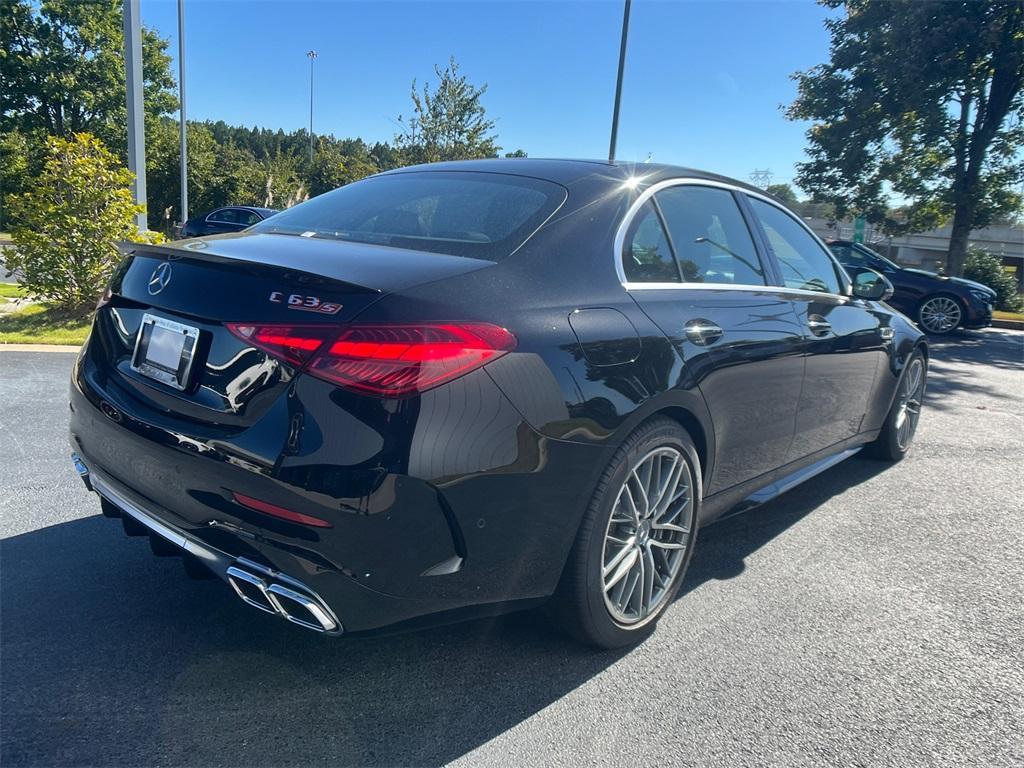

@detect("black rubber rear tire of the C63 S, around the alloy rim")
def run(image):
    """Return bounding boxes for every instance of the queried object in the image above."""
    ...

[547,417,702,648]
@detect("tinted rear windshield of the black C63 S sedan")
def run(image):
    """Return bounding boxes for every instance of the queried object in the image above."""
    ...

[250,171,566,261]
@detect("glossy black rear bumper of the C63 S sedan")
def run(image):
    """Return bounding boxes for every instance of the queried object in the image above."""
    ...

[71,353,607,634]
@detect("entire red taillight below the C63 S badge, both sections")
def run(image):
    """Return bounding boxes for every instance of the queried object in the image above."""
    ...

[227,323,515,397]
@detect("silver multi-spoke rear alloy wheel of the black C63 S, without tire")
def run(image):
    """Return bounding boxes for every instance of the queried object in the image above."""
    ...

[601,446,693,625]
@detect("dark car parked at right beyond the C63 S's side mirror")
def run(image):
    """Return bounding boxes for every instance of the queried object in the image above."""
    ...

[828,240,995,335]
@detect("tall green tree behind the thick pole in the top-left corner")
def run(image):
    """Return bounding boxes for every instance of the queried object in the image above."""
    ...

[0,0,177,155]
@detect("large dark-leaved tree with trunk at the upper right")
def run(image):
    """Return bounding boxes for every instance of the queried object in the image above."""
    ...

[787,0,1024,274]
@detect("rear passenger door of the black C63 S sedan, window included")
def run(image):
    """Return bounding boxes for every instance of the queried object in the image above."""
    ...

[622,180,804,495]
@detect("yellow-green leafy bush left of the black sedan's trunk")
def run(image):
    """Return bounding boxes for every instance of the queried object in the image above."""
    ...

[4,133,156,314]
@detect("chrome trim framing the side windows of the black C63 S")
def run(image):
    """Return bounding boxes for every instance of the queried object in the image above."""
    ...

[612,177,849,302]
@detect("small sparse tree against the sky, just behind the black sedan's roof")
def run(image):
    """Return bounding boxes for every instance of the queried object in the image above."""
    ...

[394,56,501,164]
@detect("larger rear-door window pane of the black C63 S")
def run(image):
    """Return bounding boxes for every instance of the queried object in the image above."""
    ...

[654,184,766,286]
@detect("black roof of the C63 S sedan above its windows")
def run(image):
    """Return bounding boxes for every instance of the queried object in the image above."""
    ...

[381,158,771,197]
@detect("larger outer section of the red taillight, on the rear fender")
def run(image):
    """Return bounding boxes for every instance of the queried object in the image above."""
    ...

[308,323,515,397]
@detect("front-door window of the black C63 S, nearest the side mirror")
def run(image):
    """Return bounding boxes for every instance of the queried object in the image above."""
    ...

[750,198,841,294]
